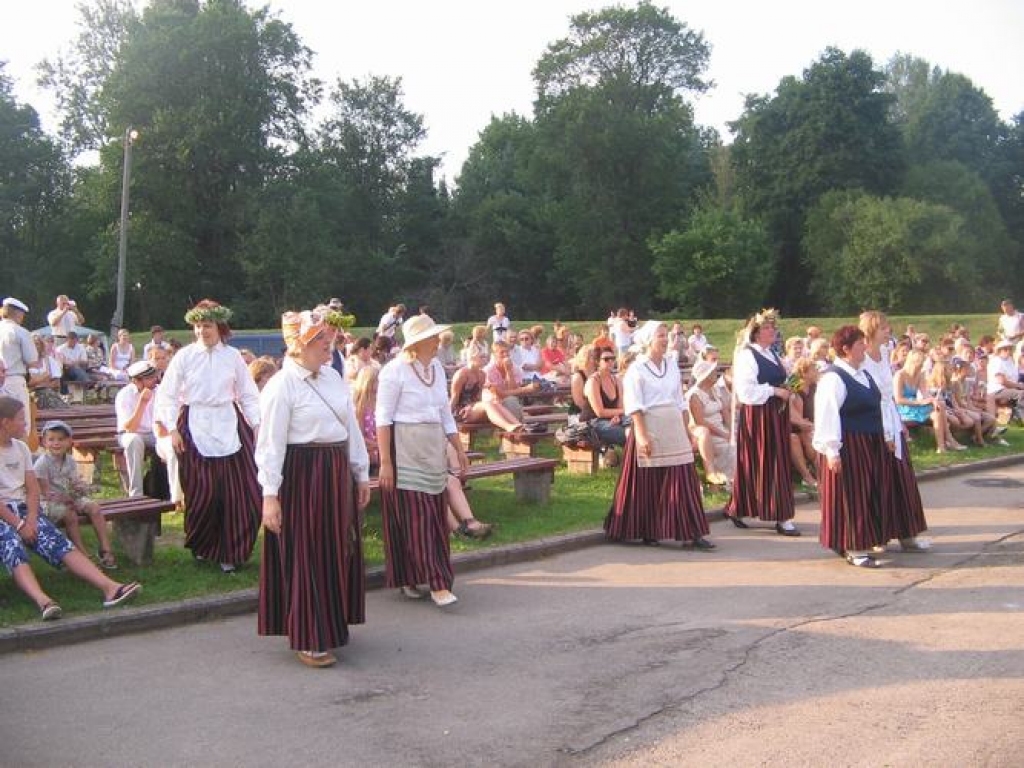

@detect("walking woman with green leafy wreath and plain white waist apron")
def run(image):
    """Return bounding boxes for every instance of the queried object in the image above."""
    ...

[155,299,262,573]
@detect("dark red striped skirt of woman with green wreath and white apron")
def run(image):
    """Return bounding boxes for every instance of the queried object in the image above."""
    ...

[178,406,263,565]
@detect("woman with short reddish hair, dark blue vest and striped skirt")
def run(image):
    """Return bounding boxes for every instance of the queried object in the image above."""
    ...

[814,326,893,568]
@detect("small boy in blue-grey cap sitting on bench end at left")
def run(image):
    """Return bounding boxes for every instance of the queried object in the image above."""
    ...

[34,421,118,570]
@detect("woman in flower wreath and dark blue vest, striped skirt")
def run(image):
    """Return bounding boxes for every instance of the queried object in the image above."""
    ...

[725,309,800,536]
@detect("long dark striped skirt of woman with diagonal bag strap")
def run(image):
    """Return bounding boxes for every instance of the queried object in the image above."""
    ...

[258,445,366,651]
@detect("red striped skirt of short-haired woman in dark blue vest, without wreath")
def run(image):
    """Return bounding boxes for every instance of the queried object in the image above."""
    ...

[818,433,889,553]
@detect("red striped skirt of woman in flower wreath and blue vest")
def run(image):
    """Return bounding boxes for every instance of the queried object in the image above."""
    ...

[725,397,796,522]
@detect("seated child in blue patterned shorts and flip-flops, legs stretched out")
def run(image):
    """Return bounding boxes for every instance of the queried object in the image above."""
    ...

[0,397,142,621]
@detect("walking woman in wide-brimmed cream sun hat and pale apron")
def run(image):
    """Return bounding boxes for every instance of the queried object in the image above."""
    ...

[376,314,468,606]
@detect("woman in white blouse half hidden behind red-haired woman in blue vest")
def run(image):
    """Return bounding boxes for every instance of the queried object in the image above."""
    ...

[859,309,931,552]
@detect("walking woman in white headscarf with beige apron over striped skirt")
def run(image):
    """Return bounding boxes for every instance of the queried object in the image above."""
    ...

[604,321,715,550]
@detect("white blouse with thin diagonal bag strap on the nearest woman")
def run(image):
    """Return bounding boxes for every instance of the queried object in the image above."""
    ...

[256,357,370,496]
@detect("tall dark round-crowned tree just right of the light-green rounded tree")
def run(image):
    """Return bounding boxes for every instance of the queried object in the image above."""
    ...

[732,48,904,313]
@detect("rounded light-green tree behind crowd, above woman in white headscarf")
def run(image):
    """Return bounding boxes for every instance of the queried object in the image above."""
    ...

[650,208,774,317]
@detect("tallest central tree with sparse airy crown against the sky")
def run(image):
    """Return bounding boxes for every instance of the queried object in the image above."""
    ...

[531,2,710,313]
